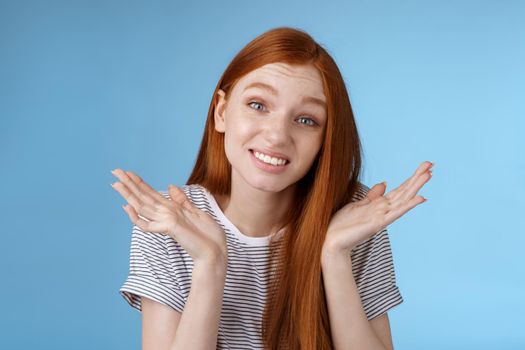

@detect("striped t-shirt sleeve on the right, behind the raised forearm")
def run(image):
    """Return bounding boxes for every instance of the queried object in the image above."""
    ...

[351,184,403,320]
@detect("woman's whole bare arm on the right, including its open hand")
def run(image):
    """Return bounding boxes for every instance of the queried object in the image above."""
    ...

[321,162,434,350]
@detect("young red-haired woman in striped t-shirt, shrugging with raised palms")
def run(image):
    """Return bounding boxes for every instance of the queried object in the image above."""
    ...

[112,27,433,350]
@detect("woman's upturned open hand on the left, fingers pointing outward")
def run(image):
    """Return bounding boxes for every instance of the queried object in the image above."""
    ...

[111,169,228,268]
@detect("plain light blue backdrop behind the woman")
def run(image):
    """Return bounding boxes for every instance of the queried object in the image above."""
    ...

[0,0,525,350]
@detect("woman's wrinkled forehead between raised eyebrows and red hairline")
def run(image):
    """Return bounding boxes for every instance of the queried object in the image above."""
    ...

[236,62,324,100]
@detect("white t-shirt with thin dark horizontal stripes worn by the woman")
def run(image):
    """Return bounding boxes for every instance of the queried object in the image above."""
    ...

[119,184,403,349]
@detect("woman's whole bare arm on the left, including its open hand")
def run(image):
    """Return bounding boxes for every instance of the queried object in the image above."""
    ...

[111,169,228,350]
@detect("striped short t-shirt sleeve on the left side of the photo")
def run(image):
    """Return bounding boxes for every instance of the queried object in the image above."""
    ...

[119,225,185,313]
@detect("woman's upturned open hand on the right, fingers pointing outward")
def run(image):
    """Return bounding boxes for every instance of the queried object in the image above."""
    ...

[323,161,434,253]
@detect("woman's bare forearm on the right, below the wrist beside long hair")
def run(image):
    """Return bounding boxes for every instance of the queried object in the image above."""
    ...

[321,252,385,350]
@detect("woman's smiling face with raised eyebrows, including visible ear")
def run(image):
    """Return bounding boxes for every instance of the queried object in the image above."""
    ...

[215,63,327,192]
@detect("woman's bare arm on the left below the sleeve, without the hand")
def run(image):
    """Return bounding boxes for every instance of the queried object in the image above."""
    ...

[142,263,226,350]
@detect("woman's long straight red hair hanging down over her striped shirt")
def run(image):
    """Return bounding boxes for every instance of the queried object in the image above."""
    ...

[186,27,361,350]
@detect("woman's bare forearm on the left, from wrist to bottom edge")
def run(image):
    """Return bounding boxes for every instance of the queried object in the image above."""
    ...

[170,260,226,350]
